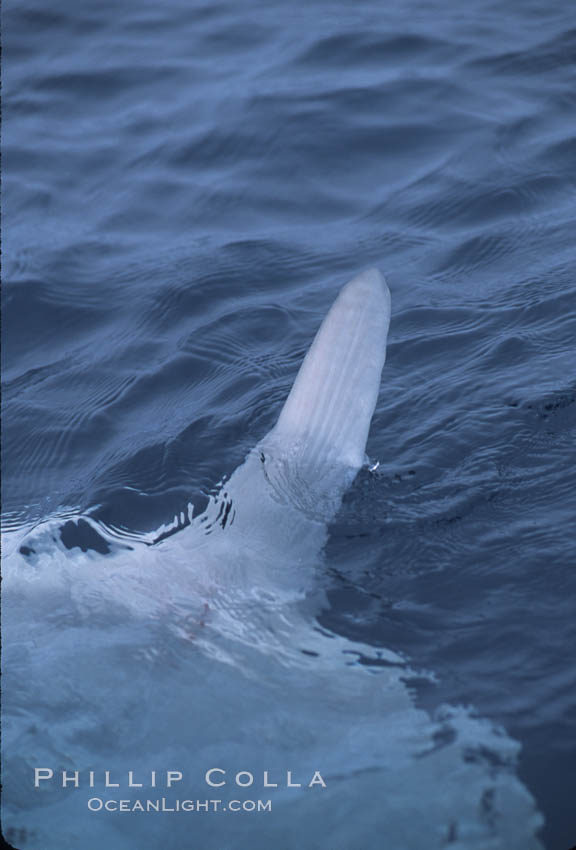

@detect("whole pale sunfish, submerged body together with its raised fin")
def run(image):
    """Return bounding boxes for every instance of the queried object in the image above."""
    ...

[3,270,541,850]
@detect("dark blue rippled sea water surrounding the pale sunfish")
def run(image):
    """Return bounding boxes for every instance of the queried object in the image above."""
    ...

[3,0,576,850]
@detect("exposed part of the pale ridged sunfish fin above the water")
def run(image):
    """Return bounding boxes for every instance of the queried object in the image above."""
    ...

[268,269,390,470]
